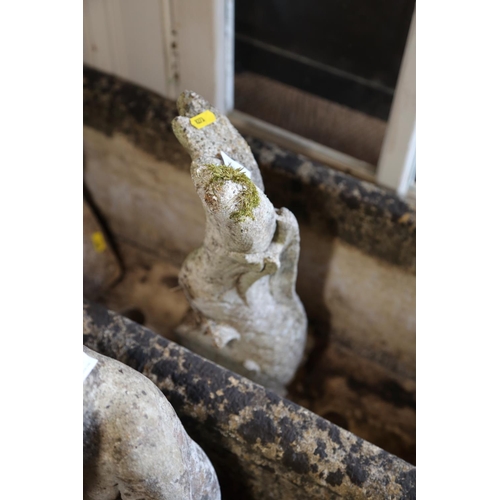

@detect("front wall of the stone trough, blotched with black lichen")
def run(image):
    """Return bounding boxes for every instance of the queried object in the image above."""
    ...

[84,304,416,500]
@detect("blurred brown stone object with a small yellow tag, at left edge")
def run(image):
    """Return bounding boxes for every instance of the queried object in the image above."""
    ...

[83,200,121,299]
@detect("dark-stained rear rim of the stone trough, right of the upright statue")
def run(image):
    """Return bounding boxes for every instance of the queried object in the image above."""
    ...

[245,137,416,273]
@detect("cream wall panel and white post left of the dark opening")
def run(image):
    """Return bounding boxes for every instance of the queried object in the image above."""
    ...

[83,0,234,111]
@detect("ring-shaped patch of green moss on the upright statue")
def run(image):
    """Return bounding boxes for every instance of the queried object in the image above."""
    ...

[205,164,260,222]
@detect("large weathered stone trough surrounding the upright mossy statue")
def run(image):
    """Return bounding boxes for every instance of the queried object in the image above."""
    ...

[84,68,416,499]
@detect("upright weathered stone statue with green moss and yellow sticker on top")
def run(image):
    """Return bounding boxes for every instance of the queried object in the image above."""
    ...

[172,91,307,394]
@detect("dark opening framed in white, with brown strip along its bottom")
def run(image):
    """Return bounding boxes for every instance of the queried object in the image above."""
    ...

[235,0,415,163]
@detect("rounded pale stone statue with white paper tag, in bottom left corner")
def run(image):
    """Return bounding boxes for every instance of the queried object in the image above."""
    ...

[83,346,220,500]
